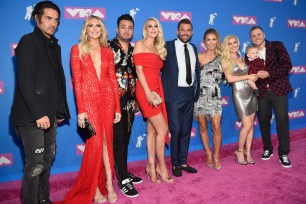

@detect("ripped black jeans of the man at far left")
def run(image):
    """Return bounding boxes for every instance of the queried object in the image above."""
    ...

[16,122,57,204]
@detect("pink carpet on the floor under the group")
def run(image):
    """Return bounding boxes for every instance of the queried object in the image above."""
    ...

[0,128,306,204]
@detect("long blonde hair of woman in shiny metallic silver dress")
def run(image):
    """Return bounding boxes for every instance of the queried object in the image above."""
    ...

[221,35,244,73]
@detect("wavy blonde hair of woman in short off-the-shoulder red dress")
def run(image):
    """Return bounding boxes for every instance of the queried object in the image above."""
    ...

[142,17,167,60]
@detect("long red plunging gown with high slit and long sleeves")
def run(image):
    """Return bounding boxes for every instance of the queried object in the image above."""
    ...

[59,45,120,204]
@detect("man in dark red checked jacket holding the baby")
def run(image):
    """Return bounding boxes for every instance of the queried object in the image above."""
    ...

[250,26,292,168]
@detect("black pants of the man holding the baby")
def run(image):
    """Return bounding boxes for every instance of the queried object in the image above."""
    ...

[258,91,290,156]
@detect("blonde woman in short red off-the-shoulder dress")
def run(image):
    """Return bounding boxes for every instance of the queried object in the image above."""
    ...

[134,17,173,183]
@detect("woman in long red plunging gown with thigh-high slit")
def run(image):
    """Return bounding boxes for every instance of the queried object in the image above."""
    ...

[59,16,121,204]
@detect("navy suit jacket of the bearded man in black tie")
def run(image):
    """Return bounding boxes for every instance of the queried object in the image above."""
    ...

[162,39,200,102]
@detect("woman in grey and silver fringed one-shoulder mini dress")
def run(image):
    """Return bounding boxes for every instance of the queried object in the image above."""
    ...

[194,28,223,170]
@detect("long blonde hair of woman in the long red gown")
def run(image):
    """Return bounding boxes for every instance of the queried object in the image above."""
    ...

[78,15,107,59]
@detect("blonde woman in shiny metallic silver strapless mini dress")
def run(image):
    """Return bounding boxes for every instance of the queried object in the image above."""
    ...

[222,35,258,165]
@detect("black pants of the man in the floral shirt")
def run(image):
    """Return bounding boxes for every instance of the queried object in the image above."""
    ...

[113,109,134,181]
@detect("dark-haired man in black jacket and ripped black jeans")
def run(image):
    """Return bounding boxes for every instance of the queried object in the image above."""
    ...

[11,1,70,204]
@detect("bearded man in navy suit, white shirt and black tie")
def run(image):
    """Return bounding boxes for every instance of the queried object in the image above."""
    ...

[162,19,200,177]
